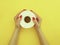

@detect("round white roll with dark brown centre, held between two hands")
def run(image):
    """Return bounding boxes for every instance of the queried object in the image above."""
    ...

[20,10,36,28]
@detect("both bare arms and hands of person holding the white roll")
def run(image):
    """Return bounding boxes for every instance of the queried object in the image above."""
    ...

[8,9,48,45]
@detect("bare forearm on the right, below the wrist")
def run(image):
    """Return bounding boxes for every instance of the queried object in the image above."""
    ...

[36,28,48,45]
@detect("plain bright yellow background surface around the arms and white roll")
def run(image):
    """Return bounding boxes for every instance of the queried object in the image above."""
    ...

[0,0,60,45]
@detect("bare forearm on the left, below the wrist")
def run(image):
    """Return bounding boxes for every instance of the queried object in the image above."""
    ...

[9,28,20,45]
